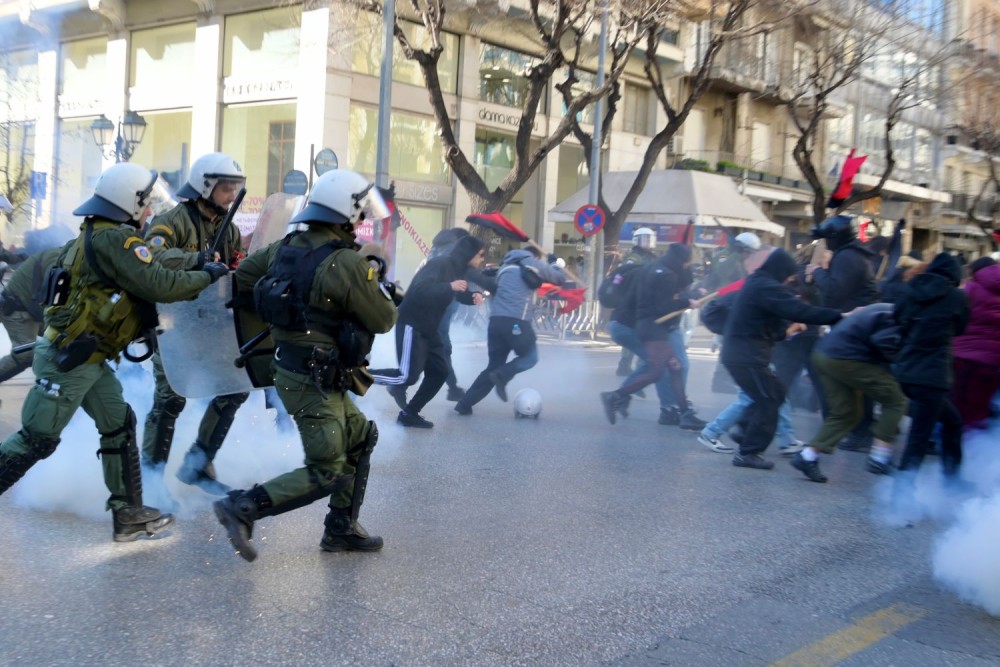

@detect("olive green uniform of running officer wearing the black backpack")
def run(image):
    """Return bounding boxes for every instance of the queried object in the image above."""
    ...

[221,224,396,560]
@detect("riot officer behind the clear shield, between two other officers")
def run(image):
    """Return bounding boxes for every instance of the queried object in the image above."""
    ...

[142,153,249,496]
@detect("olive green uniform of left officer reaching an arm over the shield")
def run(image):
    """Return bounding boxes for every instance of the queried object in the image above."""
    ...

[0,222,211,516]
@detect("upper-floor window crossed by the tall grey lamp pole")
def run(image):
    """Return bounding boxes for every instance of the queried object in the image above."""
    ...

[351,12,459,93]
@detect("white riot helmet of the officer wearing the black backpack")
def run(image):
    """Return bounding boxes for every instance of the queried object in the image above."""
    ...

[292,169,389,225]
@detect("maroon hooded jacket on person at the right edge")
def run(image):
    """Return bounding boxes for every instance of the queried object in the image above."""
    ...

[952,264,1000,368]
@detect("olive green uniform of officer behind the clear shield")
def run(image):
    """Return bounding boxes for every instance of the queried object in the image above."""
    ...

[142,200,249,478]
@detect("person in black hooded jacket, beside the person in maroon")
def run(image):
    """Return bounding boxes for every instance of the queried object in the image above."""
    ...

[893,253,969,479]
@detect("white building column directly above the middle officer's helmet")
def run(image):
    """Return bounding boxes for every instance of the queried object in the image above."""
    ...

[191,16,222,161]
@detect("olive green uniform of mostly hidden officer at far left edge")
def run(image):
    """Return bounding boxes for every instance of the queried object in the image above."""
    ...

[0,248,62,382]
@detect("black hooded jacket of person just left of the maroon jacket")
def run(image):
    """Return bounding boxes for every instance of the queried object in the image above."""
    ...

[893,252,969,389]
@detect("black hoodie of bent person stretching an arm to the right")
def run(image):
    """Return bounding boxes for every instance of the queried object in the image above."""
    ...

[722,248,841,366]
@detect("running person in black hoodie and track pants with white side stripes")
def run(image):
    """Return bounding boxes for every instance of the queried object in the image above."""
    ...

[372,236,486,428]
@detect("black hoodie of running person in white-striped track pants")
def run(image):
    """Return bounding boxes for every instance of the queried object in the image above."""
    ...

[399,236,483,336]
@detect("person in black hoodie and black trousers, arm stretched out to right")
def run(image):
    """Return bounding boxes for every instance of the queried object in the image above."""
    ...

[722,248,842,470]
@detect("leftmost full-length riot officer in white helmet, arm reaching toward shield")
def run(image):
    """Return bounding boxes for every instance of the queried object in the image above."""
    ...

[0,163,229,542]
